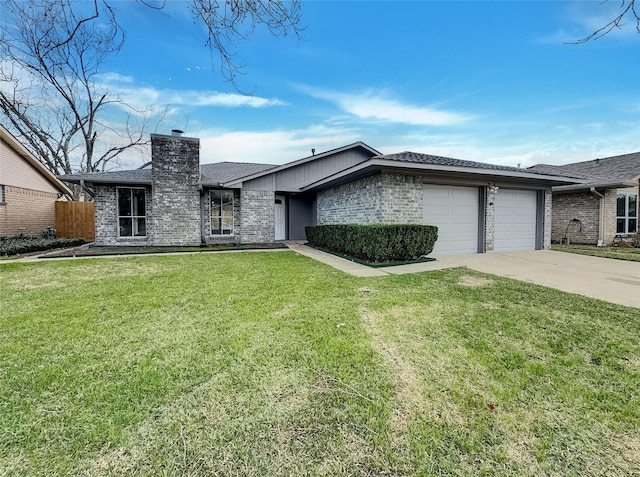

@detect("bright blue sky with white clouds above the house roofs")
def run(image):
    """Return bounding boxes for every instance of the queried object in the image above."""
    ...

[97,0,640,167]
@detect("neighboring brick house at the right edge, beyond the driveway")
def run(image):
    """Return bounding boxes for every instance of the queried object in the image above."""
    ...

[531,152,640,245]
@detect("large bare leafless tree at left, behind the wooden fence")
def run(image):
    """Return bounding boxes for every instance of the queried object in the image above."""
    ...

[0,0,158,174]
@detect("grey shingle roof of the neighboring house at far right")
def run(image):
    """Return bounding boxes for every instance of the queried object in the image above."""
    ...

[529,152,640,183]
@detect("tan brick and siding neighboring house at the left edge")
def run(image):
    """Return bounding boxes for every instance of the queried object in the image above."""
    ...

[0,125,72,237]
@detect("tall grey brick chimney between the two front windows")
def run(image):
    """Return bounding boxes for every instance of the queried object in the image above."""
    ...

[151,133,201,246]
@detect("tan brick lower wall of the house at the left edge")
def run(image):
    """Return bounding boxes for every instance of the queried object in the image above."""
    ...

[0,185,58,237]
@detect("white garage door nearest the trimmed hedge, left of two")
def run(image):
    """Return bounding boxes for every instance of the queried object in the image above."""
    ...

[423,184,480,255]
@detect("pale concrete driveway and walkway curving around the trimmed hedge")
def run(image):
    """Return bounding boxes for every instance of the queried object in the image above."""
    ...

[287,243,640,308]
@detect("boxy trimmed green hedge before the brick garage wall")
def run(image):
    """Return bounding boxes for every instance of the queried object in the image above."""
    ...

[305,224,438,263]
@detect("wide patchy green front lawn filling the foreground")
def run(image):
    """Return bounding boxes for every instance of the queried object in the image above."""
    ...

[0,252,640,476]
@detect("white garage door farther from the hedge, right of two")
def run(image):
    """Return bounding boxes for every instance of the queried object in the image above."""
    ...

[494,189,538,252]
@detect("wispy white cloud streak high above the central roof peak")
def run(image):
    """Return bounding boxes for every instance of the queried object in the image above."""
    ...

[298,86,472,126]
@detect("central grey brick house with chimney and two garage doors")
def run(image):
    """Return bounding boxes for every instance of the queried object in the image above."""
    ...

[60,134,578,254]
